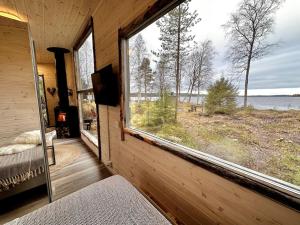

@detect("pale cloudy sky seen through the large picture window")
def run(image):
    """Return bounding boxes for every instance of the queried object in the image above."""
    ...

[134,0,300,95]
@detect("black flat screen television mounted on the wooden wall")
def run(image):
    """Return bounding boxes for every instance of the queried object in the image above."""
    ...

[92,64,119,106]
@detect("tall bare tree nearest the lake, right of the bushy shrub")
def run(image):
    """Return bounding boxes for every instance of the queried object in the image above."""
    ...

[224,0,283,107]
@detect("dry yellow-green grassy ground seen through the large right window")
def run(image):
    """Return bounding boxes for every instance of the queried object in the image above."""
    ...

[131,102,300,185]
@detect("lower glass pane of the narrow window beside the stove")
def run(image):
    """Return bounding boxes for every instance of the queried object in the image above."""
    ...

[80,92,97,138]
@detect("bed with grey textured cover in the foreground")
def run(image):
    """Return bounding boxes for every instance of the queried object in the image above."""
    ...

[6,175,171,225]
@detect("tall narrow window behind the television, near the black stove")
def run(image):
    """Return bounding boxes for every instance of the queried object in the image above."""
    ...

[76,32,97,144]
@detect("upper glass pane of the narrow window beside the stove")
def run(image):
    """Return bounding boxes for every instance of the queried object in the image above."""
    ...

[78,33,94,90]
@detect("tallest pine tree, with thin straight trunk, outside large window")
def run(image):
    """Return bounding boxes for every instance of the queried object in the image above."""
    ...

[156,0,200,120]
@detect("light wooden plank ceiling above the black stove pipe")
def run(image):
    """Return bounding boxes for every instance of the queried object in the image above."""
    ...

[0,0,100,63]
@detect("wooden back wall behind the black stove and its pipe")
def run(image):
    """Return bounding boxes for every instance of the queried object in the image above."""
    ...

[37,53,77,126]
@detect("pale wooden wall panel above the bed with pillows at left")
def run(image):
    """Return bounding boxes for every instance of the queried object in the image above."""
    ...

[0,17,40,145]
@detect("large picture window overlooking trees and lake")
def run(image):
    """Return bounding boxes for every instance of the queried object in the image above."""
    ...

[124,0,300,191]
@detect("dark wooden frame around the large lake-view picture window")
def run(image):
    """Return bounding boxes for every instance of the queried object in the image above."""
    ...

[119,0,300,211]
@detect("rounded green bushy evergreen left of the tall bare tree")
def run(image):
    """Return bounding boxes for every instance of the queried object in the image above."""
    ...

[205,77,238,115]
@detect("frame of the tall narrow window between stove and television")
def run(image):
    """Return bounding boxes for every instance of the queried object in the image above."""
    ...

[73,17,101,156]
